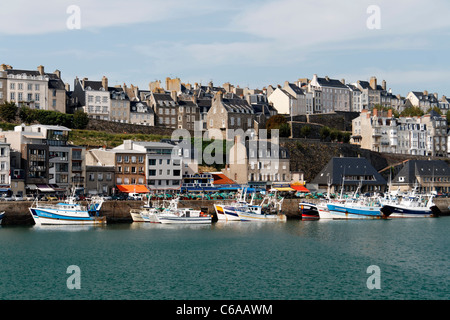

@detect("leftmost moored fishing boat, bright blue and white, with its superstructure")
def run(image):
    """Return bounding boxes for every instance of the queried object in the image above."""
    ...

[29,196,106,225]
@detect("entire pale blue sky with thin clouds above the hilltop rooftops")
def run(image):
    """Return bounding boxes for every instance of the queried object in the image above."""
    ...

[0,0,450,96]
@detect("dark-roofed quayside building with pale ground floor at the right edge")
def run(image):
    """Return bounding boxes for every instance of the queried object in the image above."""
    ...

[391,160,450,193]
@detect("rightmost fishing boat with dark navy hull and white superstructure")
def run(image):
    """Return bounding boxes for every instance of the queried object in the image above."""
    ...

[381,192,440,218]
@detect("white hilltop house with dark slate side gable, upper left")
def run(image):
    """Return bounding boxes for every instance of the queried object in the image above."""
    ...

[72,76,111,120]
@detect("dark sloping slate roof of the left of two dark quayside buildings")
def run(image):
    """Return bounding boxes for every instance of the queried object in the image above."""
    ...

[311,157,386,185]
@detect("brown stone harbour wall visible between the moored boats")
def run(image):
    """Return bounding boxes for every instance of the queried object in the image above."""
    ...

[0,198,450,226]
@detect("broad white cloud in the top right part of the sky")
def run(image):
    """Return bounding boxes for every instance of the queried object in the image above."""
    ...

[232,0,450,48]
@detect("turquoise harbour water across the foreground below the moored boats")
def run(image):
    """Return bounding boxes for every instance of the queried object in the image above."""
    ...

[0,217,450,300]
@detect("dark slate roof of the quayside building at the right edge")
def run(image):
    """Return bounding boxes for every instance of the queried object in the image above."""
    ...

[392,160,450,184]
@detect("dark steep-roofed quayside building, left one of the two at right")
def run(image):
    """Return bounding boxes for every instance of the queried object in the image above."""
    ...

[310,157,386,193]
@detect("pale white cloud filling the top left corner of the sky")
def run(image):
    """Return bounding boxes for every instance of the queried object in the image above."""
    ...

[0,0,221,35]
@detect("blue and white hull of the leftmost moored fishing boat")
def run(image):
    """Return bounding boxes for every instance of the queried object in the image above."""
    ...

[29,208,106,225]
